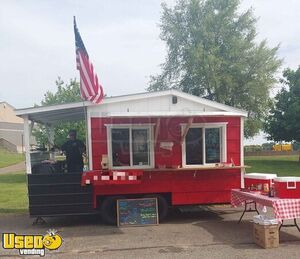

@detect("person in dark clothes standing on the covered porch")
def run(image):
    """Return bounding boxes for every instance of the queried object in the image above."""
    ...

[61,130,86,173]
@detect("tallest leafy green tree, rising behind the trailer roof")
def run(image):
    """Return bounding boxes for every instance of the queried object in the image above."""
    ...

[148,0,281,137]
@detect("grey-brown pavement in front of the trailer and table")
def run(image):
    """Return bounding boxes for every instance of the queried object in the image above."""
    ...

[0,206,300,259]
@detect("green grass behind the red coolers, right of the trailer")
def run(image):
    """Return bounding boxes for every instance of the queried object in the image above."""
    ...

[245,155,300,176]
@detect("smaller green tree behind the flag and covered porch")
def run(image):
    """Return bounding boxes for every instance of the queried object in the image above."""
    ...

[32,77,86,147]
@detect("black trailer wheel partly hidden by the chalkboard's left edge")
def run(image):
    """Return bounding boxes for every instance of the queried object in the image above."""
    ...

[100,196,125,225]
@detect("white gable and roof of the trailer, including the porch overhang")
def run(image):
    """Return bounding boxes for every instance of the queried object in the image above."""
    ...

[16,89,247,124]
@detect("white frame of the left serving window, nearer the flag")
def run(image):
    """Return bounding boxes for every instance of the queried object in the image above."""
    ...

[105,123,155,170]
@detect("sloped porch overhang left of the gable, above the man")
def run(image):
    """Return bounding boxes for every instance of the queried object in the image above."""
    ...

[16,102,87,125]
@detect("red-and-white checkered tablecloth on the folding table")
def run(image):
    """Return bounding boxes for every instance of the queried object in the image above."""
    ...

[231,190,300,221]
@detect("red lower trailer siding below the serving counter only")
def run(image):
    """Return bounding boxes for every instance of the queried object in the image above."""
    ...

[93,169,241,208]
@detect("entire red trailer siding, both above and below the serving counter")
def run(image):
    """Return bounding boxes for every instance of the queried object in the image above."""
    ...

[91,117,241,207]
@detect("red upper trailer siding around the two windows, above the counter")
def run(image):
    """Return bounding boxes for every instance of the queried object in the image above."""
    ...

[91,117,241,170]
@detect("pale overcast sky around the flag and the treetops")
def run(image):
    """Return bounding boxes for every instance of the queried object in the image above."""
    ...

[0,0,300,144]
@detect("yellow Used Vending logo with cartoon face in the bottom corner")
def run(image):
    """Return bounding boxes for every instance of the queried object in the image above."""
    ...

[2,229,63,256]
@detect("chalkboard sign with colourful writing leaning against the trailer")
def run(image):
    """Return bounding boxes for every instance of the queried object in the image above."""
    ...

[117,198,158,227]
